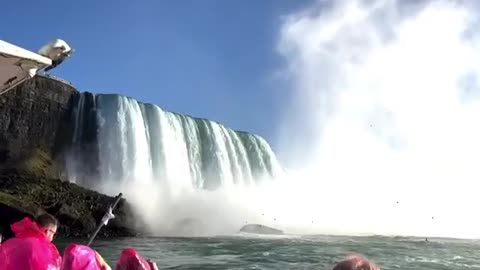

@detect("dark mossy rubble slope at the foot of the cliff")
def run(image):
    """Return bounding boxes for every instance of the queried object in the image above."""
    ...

[0,170,136,238]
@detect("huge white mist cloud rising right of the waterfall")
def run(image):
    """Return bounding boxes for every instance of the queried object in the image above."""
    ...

[272,0,480,237]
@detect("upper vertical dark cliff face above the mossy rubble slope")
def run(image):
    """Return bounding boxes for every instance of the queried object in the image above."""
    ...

[0,76,78,176]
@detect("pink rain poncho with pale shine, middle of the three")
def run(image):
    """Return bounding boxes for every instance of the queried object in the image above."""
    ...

[62,244,111,270]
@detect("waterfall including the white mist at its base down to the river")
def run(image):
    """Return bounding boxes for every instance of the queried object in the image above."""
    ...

[66,92,282,235]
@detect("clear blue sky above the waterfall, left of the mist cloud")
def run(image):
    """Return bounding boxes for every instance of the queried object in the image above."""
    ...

[0,0,310,158]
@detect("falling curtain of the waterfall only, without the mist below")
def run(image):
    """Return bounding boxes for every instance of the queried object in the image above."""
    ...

[67,92,281,192]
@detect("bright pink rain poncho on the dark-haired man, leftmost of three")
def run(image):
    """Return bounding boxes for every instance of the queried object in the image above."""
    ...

[0,217,62,270]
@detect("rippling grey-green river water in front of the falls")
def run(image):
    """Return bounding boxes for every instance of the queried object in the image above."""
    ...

[59,236,480,270]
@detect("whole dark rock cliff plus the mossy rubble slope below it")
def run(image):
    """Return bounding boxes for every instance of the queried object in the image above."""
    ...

[0,76,137,238]
